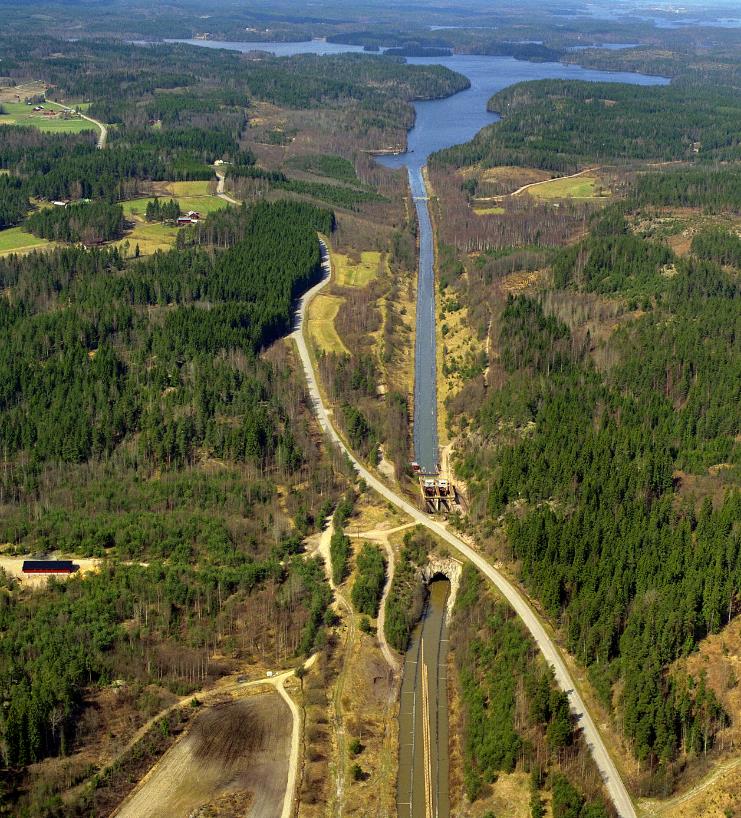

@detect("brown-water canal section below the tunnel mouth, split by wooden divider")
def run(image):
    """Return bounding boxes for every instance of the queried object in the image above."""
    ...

[397,578,450,818]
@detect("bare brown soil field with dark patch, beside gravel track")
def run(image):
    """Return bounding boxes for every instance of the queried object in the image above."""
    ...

[114,691,291,818]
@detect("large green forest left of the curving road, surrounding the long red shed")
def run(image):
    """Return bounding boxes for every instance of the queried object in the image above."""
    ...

[0,196,346,784]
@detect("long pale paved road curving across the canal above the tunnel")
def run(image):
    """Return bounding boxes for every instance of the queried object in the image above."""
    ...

[292,242,636,818]
